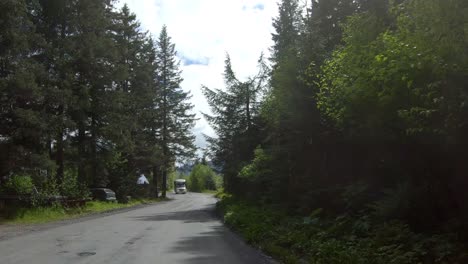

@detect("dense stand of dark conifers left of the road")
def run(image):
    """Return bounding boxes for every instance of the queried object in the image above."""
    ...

[0,0,195,197]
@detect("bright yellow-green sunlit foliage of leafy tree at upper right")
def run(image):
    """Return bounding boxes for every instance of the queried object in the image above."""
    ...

[319,0,467,142]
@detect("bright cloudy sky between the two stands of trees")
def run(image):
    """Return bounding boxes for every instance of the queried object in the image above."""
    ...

[117,0,277,153]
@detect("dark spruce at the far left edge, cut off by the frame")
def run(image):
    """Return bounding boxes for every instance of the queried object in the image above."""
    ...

[0,0,50,176]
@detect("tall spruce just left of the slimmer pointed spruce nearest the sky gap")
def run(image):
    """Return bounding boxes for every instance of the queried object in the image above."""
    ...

[103,5,160,197]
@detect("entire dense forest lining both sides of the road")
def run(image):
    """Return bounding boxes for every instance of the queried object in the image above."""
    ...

[0,0,468,264]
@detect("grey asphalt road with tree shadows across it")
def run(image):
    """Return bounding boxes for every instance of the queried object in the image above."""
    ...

[0,193,269,264]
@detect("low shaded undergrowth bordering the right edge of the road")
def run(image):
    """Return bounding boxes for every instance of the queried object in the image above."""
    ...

[218,195,463,264]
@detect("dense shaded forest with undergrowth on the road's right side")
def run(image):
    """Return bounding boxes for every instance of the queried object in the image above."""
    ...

[203,0,468,263]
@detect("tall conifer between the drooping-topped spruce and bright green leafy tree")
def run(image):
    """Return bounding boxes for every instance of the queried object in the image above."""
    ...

[263,0,355,205]
